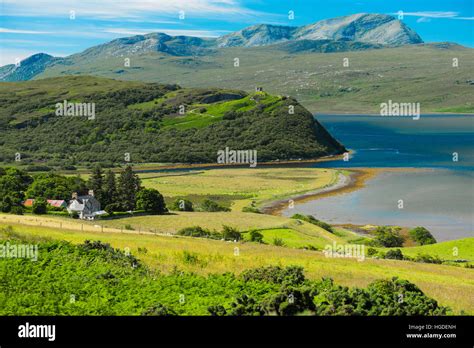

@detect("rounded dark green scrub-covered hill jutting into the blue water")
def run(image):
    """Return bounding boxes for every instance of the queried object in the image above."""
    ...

[0,76,344,165]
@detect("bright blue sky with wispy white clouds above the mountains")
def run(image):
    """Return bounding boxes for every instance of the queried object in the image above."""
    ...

[0,0,474,65]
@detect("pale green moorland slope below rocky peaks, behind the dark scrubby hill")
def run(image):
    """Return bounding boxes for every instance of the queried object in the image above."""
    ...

[37,45,474,113]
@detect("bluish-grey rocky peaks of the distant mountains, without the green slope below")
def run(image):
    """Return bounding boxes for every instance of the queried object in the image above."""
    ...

[0,13,423,81]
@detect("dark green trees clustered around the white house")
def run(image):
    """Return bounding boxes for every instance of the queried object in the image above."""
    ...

[0,166,168,214]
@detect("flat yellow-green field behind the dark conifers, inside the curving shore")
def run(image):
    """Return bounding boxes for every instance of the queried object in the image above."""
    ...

[140,168,339,211]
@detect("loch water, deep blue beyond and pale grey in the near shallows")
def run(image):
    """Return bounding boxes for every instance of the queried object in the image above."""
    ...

[283,115,474,241]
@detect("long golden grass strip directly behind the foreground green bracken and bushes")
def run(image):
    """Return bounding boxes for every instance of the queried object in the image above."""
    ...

[0,220,474,314]
